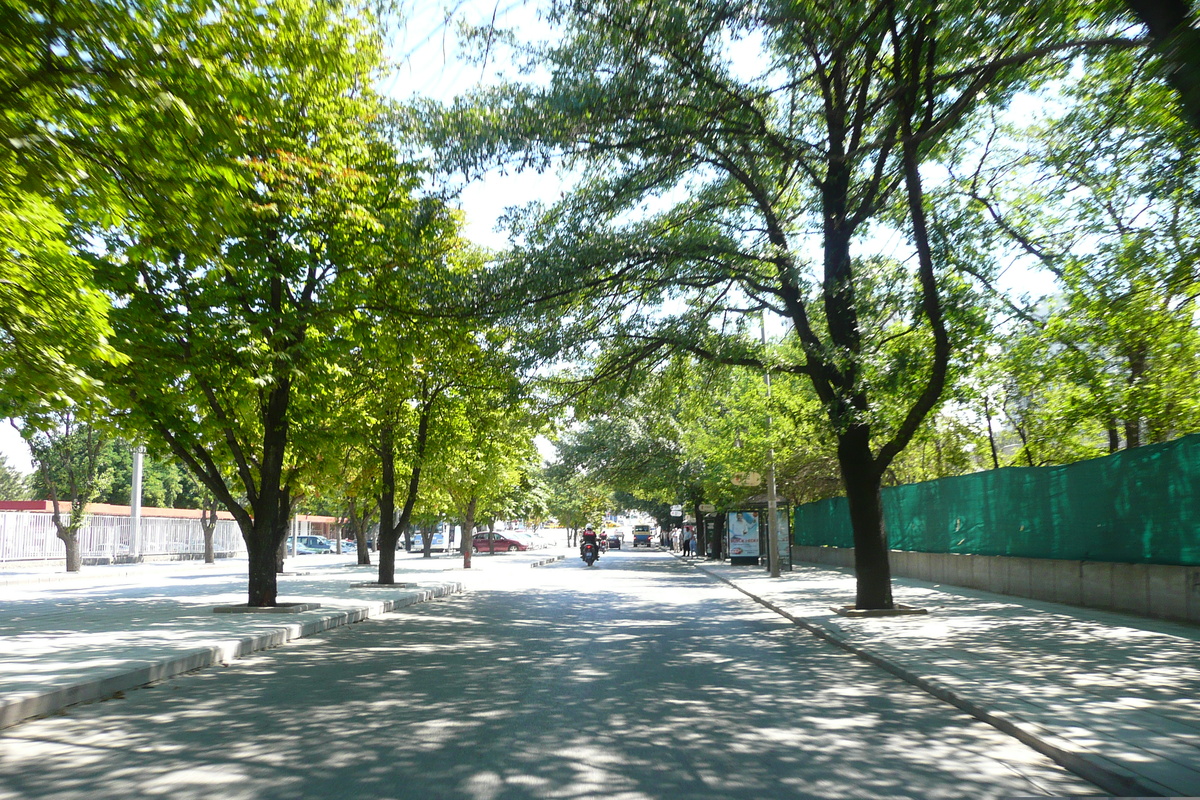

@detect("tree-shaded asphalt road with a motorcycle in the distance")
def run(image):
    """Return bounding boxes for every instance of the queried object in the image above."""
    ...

[0,551,1100,800]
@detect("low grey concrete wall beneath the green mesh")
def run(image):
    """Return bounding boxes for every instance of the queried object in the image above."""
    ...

[792,546,1200,624]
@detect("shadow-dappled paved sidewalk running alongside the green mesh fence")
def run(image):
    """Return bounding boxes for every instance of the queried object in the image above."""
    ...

[692,560,1200,798]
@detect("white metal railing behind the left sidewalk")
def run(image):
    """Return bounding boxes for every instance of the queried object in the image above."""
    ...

[0,511,261,563]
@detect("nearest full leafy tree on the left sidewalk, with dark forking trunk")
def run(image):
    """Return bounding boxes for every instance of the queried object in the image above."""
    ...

[101,1,410,606]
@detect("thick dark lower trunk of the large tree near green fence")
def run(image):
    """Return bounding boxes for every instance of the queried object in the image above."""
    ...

[838,426,894,608]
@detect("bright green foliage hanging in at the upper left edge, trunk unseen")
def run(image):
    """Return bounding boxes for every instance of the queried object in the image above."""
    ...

[0,0,226,416]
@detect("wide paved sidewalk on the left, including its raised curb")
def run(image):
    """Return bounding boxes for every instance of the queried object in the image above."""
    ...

[0,555,492,728]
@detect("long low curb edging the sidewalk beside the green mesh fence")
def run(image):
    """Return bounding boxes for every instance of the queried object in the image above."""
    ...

[680,559,1172,798]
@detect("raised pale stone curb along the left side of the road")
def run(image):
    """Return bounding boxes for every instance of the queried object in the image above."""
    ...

[0,582,463,728]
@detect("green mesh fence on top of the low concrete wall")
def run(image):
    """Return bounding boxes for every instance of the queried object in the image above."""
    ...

[792,434,1200,566]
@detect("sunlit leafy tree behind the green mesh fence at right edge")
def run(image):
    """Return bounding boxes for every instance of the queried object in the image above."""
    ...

[964,47,1200,463]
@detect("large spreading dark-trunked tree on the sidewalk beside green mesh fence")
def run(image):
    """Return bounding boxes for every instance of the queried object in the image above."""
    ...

[436,0,1121,608]
